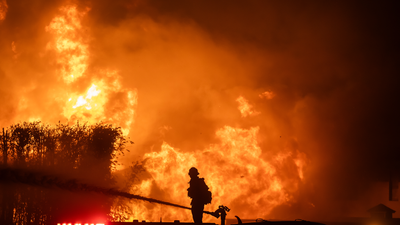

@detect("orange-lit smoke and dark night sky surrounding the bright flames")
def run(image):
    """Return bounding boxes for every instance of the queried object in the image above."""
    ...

[0,0,400,221]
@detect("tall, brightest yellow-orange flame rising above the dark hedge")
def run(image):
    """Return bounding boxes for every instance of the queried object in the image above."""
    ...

[46,5,137,135]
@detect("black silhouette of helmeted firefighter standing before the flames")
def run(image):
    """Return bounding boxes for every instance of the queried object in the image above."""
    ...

[187,167,212,223]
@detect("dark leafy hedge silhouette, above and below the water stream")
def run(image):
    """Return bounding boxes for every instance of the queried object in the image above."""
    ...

[0,122,127,224]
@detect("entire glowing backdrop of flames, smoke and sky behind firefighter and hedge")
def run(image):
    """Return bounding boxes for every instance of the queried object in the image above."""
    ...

[0,0,400,222]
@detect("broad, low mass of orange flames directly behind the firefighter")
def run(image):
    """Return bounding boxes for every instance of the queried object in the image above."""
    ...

[131,126,307,221]
